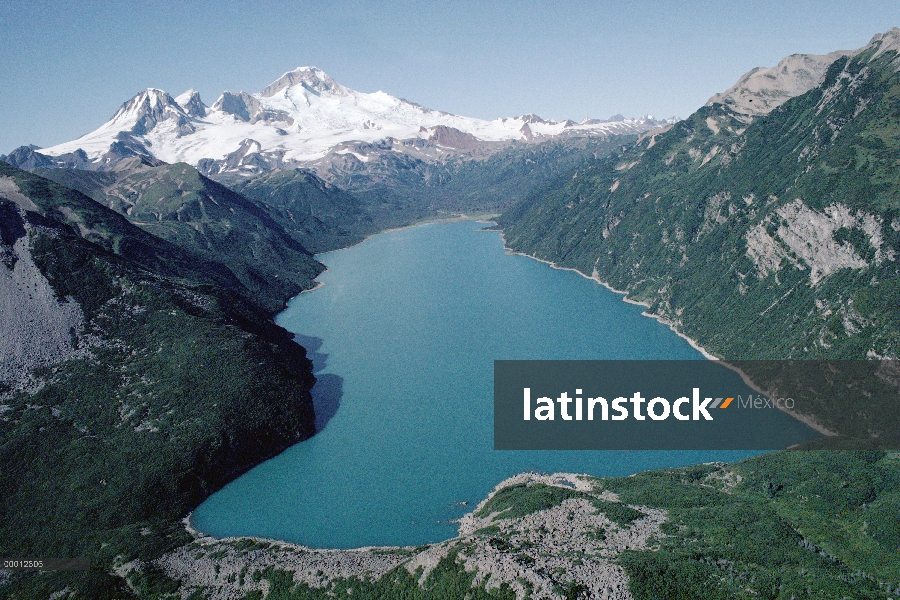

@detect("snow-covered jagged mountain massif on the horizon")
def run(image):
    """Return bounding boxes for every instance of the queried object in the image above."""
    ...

[40,67,664,176]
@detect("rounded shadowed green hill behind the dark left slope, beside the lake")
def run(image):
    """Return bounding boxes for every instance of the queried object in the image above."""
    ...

[39,159,322,314]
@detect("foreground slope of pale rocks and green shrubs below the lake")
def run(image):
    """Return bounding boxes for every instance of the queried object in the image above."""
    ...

[130,452,900,600]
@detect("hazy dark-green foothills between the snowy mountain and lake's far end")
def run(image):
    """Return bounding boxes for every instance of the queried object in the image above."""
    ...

[26,136,635,280]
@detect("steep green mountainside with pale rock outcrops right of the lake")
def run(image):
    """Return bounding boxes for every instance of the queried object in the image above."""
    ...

[500,29,900,359]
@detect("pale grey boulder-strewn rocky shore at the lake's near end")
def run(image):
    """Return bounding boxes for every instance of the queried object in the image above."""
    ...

[158,472,668,600]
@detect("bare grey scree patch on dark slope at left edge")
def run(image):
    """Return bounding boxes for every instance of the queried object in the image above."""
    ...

[0,183,84,388]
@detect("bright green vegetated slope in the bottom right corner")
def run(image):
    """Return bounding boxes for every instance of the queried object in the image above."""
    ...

[603,451,900,599]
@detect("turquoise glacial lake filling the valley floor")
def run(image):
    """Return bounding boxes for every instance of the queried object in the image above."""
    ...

[192,221,815,548]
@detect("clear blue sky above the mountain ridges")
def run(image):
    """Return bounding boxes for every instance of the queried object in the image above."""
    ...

[0,0,900,153]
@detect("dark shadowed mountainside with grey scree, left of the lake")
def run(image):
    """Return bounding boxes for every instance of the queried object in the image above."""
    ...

[0,163,314,598]
